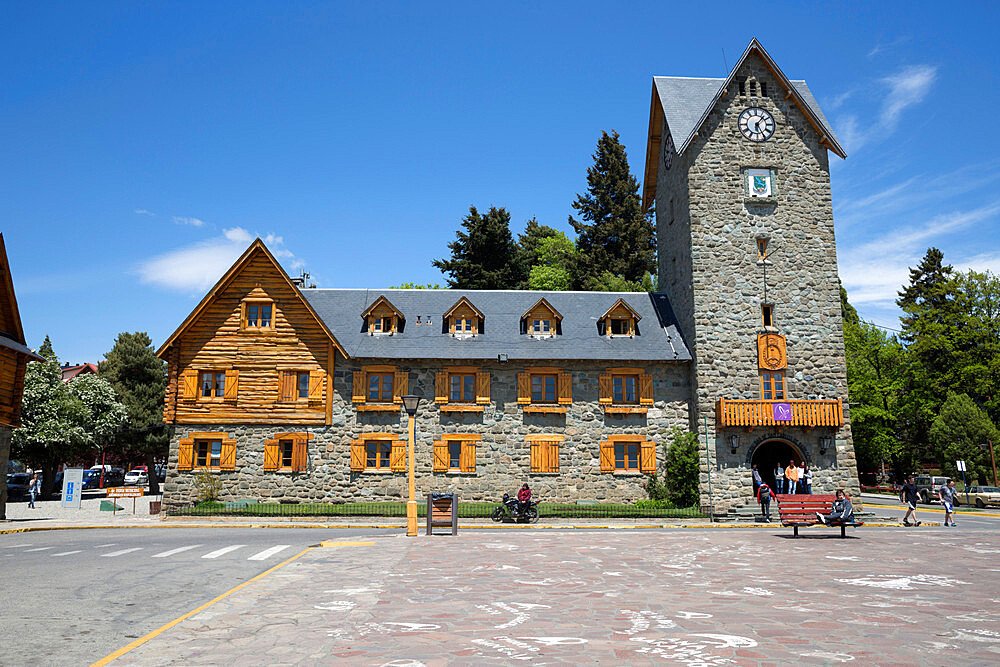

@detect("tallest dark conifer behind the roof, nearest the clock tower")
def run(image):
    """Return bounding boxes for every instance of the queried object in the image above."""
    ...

[569,130,656,289]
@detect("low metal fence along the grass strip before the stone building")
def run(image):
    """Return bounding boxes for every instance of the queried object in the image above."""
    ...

[167,498,706,519]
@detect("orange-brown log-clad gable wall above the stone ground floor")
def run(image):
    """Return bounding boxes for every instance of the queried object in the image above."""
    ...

[157,239,347,424]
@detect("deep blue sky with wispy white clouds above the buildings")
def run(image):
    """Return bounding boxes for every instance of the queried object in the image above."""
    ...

[0,2,1000,362]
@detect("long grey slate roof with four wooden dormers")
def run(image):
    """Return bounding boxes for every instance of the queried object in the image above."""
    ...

[301,289,691,362]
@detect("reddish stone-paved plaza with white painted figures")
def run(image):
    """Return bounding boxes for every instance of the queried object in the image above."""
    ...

[118,527,1000,666]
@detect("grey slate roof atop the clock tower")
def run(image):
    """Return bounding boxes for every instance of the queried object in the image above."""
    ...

[653,76,839,154]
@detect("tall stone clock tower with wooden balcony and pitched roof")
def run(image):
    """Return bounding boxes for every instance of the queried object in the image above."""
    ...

[643,39,860,511]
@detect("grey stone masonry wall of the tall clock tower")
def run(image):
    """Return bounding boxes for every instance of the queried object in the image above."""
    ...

[656,54,858,506]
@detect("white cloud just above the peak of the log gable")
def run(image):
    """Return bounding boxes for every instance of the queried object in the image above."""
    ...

[137,227,294,292]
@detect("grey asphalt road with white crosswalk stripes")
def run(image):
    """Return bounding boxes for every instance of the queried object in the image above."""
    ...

[0,527,399,665]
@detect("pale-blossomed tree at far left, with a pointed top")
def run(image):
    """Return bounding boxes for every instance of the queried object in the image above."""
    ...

[11,336,90,497]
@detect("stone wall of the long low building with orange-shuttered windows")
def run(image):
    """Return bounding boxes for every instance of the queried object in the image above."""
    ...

[164,358,690,509]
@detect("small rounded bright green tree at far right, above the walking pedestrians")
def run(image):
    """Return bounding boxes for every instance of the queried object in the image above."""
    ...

[930,392,1000,483]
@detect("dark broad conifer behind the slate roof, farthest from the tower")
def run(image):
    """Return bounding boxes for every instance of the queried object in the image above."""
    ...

[431,206,524,289]
